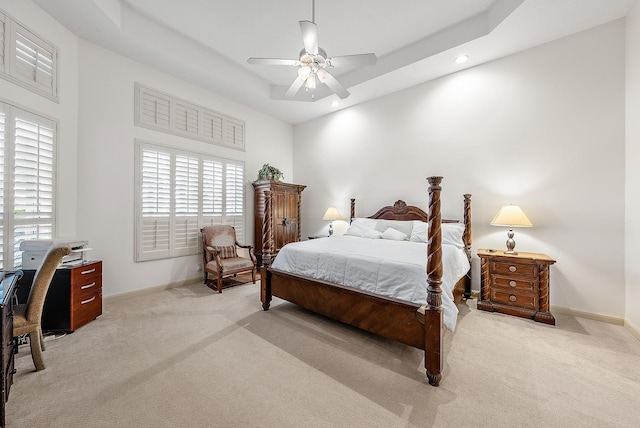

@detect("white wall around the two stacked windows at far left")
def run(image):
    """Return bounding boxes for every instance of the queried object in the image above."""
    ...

[0,0,78,237]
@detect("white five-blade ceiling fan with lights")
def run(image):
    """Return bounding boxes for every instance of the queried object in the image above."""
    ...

[247,0,378,99]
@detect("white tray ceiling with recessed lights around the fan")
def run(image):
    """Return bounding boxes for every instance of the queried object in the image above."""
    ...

[34,0,636,124]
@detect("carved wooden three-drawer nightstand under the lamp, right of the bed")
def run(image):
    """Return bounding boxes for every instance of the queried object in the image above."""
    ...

[478,250,556,325]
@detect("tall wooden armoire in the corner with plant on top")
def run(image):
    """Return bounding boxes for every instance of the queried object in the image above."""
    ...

[253,180,307,266]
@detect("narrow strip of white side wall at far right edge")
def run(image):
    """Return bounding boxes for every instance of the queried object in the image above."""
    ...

[625,4,640,337]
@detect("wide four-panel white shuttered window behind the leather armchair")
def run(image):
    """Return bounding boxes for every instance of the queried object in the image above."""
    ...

[134,139,247,262]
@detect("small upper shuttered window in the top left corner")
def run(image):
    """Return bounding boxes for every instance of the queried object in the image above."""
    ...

[0,11,58,101]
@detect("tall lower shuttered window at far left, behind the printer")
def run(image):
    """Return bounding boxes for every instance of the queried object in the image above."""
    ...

[0,102,56,269]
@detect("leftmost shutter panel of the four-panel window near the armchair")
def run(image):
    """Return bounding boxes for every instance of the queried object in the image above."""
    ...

[138,150,171,259]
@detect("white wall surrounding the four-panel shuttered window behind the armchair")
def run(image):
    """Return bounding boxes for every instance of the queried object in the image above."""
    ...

[78,41,293,295]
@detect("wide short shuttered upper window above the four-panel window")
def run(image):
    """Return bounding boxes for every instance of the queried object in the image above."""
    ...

[135,83,245,150]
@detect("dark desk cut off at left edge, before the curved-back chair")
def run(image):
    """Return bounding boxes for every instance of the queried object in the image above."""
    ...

[0,271,22,427]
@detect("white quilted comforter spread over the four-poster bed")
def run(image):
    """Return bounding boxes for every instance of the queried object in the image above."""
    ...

[272,236,469,331]
